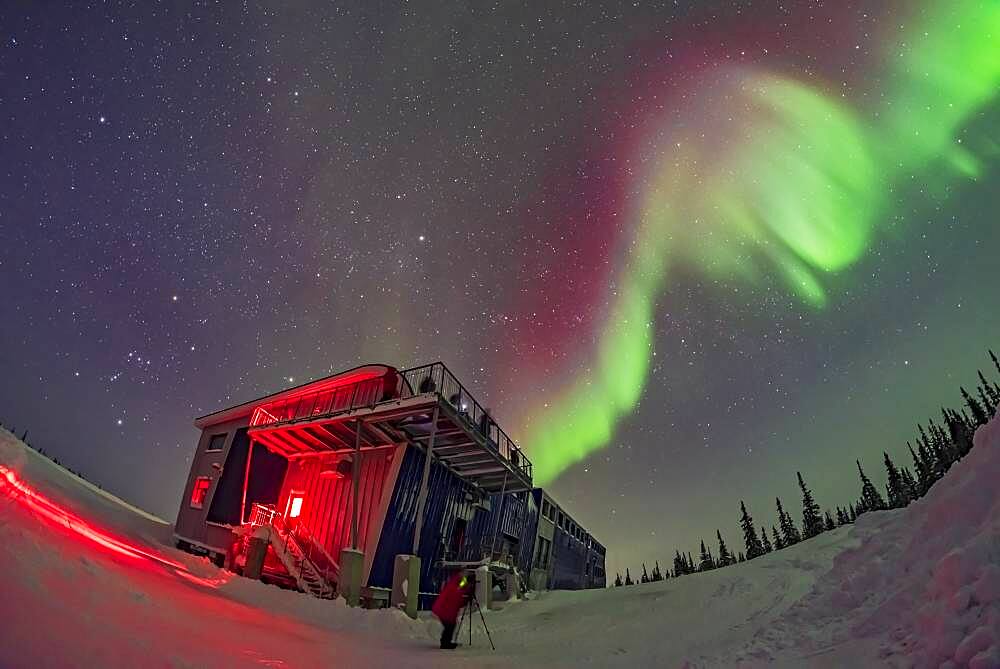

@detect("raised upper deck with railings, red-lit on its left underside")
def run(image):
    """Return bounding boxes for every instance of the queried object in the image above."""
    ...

[244,362,532,493]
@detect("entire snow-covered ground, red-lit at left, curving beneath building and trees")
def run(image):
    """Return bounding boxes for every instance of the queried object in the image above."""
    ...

[0,420,1000,669]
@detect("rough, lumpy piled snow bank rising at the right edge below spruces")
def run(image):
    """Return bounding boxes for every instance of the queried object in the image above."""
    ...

[740,417,1000,669]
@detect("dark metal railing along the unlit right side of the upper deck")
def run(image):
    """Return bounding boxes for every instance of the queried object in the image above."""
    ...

[400,362,532,481]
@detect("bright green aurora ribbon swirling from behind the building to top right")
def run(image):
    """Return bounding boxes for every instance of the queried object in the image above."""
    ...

[525,0,1000,485]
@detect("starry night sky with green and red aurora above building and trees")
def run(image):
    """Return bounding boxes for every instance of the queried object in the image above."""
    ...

[0,0,1000,577]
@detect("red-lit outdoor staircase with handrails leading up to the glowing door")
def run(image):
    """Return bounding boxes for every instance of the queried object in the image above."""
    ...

[250,504,340,599]
